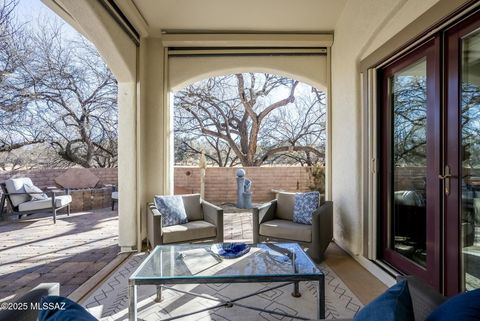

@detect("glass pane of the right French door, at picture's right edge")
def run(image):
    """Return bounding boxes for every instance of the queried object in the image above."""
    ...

[460,31,480,290]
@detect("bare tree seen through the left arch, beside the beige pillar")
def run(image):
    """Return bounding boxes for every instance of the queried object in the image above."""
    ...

[0,17,118,167]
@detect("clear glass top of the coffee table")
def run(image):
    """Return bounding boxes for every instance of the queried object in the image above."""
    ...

[130,243,323,280]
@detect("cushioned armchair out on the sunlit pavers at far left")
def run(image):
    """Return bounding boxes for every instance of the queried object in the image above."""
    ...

[0,177,72,223]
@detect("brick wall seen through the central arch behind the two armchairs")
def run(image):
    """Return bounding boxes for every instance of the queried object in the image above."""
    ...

[174,166,311,203]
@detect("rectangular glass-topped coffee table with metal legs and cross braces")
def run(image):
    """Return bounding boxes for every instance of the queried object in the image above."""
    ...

[128,243,325,321]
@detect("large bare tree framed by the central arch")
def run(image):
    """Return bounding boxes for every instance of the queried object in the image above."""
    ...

[175,73,325,166]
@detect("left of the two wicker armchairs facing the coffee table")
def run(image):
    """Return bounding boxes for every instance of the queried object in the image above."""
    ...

[147,194,223,248]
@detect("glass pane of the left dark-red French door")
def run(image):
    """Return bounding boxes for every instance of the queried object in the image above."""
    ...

[389,59,427,266]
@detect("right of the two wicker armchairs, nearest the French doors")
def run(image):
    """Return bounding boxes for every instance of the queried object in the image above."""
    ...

[253,192,333,261]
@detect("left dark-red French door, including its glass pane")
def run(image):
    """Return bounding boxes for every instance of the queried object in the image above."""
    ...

[379,39,441,288]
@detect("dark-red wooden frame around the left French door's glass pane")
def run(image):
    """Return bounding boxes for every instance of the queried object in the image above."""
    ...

[378,37,441,289]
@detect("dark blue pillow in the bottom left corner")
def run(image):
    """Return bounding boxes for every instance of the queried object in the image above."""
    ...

[38,295,98,321]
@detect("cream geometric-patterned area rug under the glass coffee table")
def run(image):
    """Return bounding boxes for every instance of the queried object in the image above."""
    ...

[83,254,362,321]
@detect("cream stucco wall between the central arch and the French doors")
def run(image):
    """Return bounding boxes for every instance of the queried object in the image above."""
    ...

[332,0,438,254]
